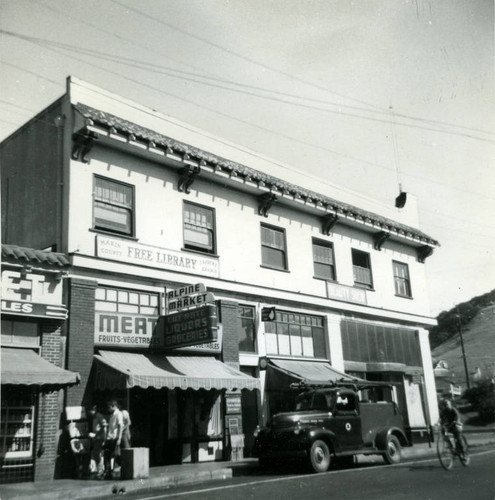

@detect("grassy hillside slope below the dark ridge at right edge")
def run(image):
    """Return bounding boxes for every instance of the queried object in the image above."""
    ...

[432,305,495,387]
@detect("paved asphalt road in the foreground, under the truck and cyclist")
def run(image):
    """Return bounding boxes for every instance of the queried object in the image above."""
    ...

[117,450,495,500]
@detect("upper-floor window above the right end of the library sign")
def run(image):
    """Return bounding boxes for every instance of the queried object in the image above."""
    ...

[184,201,215,253]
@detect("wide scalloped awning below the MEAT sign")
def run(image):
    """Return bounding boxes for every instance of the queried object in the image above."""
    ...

[95,351,260,390]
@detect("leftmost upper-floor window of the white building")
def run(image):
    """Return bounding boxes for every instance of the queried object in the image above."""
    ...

[93,176,134,236]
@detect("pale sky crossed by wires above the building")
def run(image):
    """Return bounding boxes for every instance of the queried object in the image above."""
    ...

[0,0,495,316]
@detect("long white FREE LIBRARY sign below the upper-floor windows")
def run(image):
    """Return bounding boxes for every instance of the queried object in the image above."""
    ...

[96,234,219,278]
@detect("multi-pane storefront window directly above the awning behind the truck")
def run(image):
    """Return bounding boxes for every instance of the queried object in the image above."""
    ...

[265,311,328,359]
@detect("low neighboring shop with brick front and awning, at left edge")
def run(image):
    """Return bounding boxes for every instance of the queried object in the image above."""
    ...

[0,245,79,484]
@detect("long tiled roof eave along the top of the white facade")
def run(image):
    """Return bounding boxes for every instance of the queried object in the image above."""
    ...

[75,103,439,246]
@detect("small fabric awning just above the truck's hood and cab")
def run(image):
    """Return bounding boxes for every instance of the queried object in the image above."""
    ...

[266,359,363,391]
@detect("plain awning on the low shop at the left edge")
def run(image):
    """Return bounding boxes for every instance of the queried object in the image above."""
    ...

[1,347,79,386]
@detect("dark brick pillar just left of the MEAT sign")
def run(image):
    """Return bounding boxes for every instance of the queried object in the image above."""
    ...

[67,278,96,406]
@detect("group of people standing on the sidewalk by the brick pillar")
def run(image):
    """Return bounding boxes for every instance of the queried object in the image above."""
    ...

[69,399,131,479]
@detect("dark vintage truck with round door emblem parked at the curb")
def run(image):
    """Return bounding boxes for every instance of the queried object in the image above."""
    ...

[253,384,410,472]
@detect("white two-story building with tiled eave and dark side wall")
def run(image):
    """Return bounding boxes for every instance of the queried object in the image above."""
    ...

[0,78,438,474]
